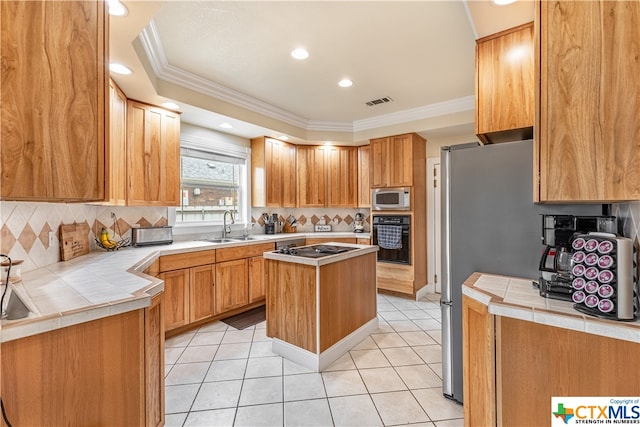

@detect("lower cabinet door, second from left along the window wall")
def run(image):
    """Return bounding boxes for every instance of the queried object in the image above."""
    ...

[189,264,216,322]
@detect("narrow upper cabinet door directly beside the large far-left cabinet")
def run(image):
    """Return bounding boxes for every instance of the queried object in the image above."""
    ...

[105,80,127,206]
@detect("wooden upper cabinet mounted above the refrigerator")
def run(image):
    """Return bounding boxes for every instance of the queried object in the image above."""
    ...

[476,22,535,143]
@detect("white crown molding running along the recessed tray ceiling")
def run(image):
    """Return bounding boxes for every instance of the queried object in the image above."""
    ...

[139,19,475,132]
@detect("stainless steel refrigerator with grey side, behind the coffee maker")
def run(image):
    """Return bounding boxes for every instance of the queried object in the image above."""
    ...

[440,140,609,402]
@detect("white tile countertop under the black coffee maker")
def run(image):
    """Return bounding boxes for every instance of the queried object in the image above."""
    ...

[462,273,640,343]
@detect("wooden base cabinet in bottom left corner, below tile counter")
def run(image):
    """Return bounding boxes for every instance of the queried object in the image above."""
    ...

[1,293,165,426]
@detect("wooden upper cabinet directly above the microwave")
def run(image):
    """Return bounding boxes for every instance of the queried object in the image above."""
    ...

[370,133,426,187]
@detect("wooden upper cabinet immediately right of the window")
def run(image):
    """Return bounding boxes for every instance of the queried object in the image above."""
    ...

[251,137,298,207]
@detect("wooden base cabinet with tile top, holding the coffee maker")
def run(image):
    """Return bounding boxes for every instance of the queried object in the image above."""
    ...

[462,273,640,426]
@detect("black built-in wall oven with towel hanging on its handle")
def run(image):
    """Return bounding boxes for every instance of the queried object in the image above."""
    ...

[371,215,411,265]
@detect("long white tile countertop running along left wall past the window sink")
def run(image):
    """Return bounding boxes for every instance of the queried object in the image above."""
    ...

[0,232,369,342]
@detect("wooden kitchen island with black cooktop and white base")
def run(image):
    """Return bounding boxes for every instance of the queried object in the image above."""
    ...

[263,242,378,372]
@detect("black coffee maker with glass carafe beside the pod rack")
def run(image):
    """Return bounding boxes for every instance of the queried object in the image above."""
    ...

[537,214,617,301]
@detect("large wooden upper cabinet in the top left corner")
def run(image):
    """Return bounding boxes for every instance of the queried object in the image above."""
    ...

[0,1,109,201]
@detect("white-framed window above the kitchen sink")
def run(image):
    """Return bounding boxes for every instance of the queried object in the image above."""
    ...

[175,146,248,224]
